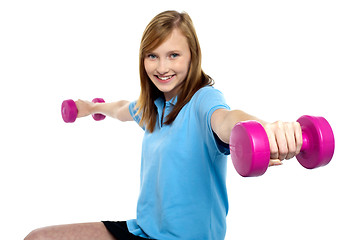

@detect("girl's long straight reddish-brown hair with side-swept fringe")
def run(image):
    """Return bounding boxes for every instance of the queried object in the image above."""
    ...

[135,11,214,132]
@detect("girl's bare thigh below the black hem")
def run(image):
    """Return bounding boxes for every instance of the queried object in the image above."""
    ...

[25,222,116,240]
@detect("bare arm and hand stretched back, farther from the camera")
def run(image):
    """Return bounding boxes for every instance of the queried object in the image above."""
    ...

[75,99,133,122]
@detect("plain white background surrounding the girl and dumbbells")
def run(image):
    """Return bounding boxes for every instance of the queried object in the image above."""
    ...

[0,0,361,240]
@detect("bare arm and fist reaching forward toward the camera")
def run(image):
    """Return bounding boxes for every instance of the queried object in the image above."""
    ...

[211,109,302,165]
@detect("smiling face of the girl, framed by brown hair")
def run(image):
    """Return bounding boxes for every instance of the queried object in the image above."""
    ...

[144,29,191,101]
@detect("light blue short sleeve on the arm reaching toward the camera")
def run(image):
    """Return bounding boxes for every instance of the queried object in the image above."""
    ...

[196,87,230,155]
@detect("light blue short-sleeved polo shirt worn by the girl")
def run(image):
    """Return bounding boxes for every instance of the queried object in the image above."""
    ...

[127,86,229,240]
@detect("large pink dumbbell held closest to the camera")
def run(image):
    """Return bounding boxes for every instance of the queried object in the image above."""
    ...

[229,115,335,177]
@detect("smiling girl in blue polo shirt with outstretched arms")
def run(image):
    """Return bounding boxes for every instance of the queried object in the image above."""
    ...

[26,11,302,240]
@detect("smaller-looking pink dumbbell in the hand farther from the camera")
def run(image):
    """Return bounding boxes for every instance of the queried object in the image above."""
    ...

[61,98,105,123]
